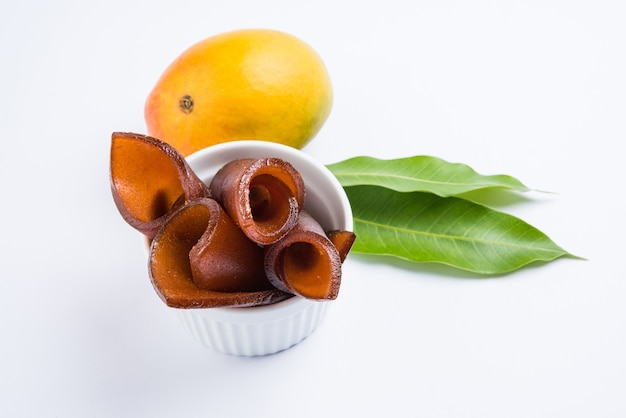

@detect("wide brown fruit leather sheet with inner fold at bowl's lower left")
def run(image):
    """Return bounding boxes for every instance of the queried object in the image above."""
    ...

[149,198,291,308]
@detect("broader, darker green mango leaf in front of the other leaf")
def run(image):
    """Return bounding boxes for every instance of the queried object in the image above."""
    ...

[345,186,568,274]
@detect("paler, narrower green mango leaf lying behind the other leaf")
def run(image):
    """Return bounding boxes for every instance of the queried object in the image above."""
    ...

[326,156,529,196]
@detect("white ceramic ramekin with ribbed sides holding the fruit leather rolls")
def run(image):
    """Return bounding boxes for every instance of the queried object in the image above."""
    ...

[176,140,353,356]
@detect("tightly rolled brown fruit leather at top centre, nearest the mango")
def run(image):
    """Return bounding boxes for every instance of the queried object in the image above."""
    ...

[209,158,305,245]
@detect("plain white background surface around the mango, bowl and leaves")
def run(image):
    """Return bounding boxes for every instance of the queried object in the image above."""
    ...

[0,0,626,418]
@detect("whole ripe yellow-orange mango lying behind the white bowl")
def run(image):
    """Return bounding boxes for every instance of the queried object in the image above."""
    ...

[144,29,333,156]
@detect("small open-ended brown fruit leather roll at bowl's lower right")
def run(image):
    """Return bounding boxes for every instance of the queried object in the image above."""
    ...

[265,211,354,300]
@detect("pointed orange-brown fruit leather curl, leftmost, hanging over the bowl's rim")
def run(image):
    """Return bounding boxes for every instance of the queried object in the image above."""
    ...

[110,132,209,238]
